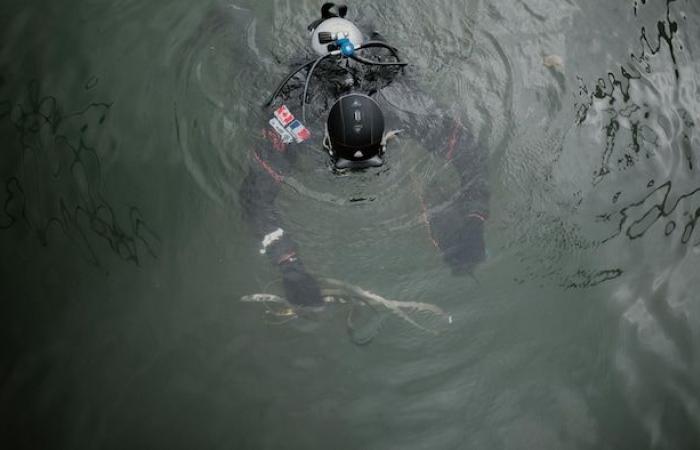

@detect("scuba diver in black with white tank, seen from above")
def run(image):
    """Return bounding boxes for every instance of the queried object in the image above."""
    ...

[240,3,488,306]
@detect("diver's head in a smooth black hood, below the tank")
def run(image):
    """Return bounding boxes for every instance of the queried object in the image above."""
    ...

[324,94,385,169]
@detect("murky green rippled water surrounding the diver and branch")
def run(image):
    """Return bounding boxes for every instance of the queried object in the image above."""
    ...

[0,0,700,449]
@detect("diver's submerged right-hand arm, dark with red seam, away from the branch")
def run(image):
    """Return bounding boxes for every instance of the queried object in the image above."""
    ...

[411,116,489,273]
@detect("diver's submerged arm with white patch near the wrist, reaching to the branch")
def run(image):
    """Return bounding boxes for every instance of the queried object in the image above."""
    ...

[240,130,322,306]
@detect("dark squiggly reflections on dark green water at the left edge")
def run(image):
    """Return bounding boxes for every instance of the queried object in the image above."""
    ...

[0,78,158,266]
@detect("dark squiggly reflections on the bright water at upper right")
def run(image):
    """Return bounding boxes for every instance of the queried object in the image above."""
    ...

[576,0,700,250]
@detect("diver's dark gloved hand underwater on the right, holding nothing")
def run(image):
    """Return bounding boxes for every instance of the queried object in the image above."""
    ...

[429,207,486,275]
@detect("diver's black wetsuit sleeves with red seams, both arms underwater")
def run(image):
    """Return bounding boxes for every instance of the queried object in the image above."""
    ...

[240,67,489,305]
